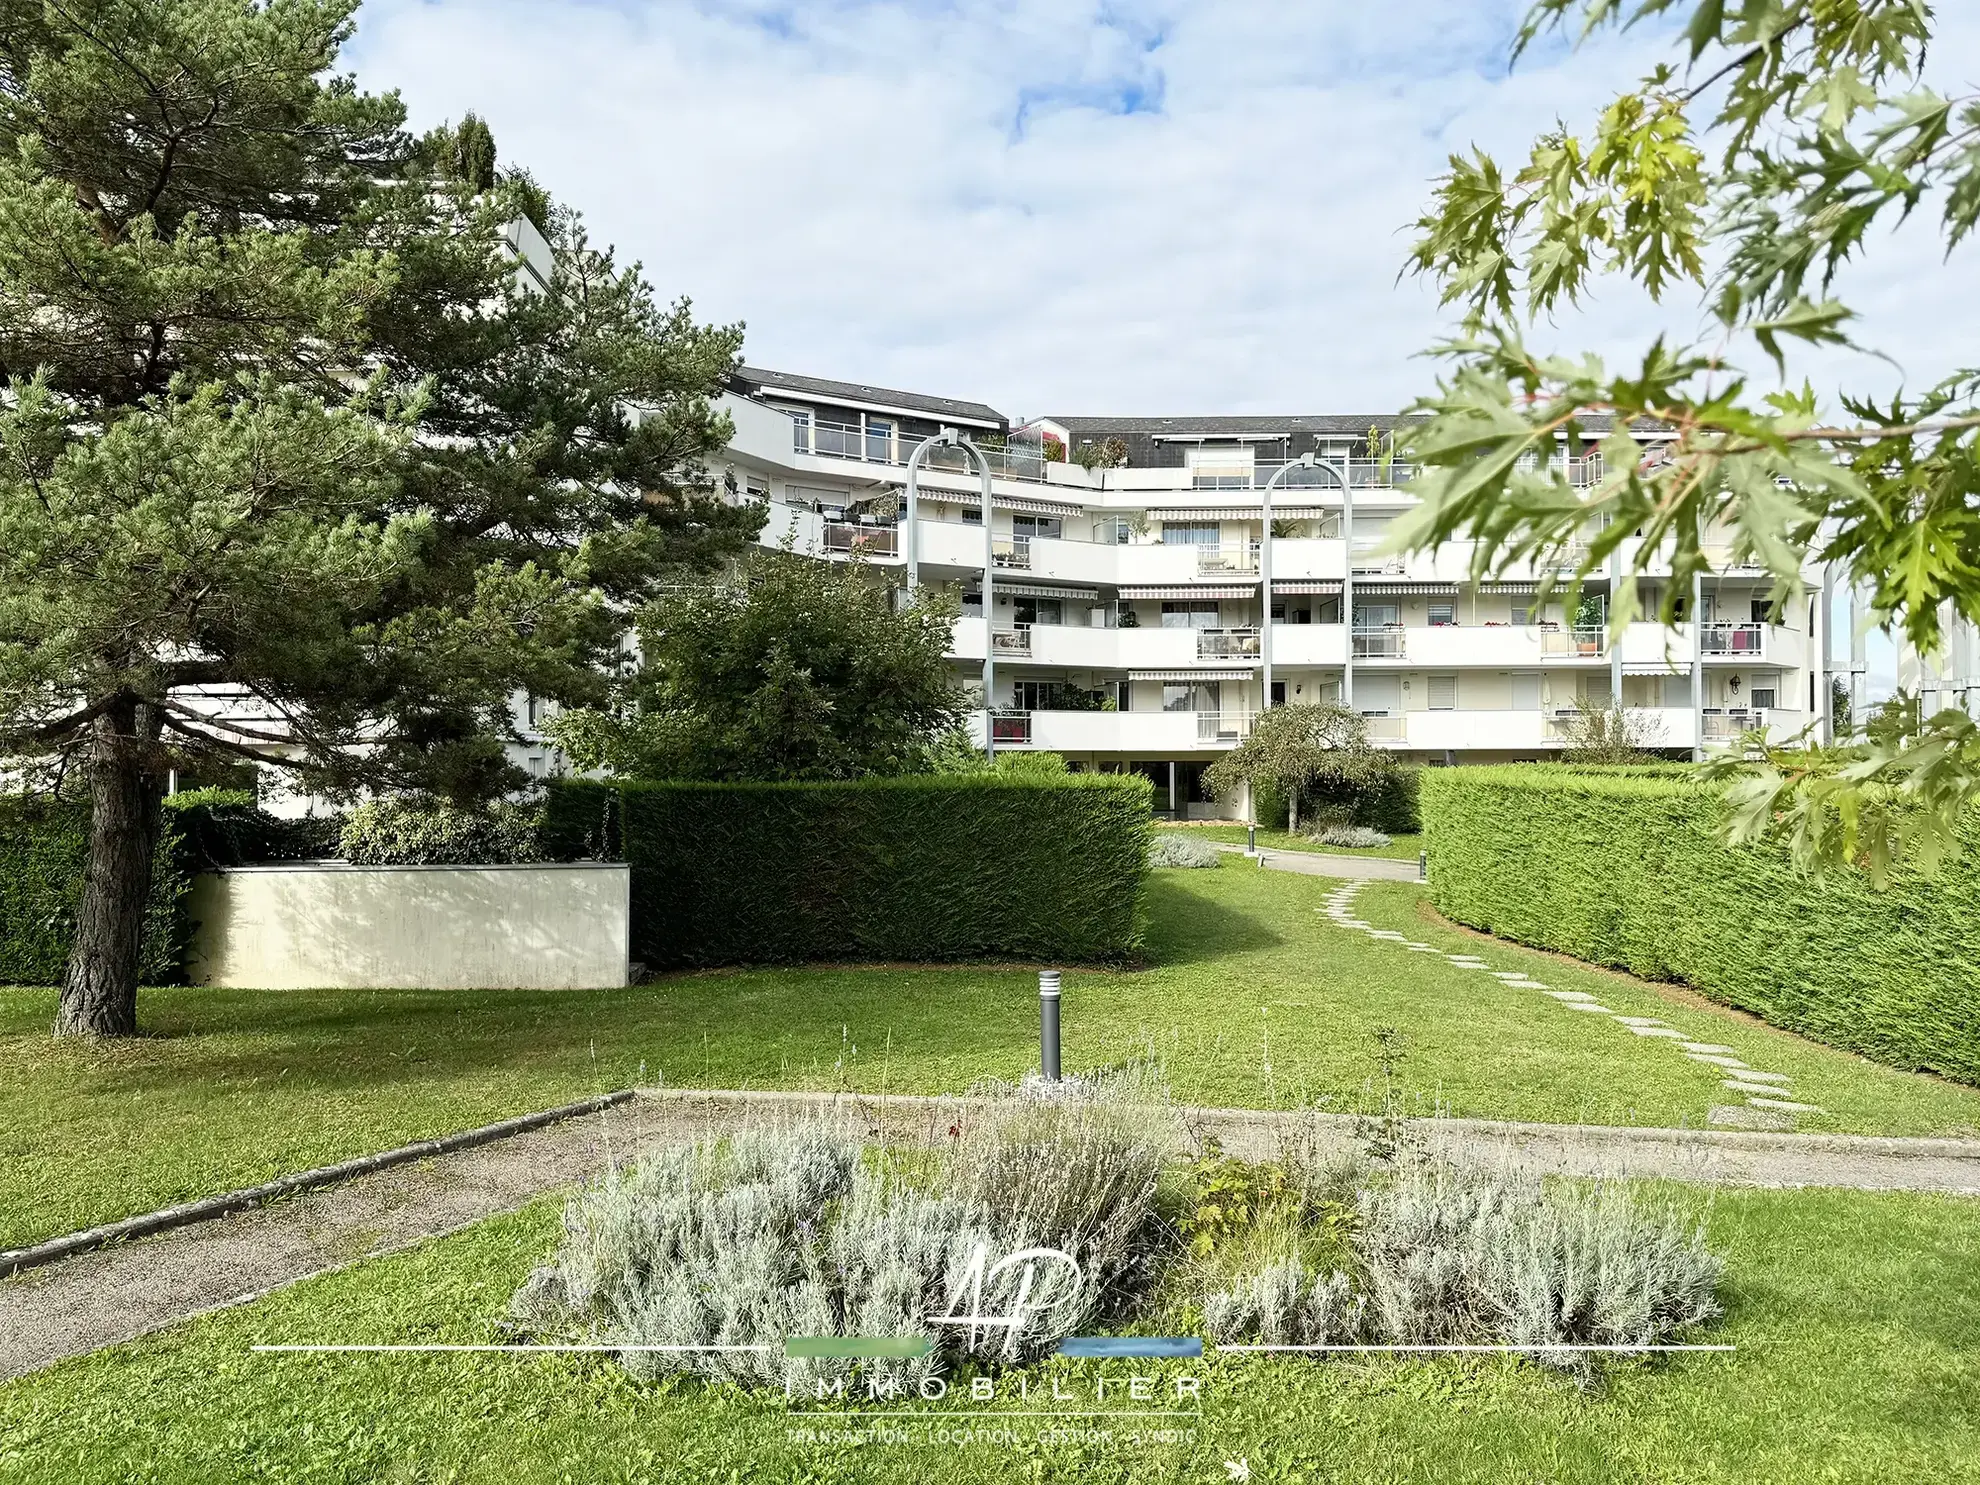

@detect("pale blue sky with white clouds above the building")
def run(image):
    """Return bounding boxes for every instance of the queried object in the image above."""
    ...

[350,0,1980,414]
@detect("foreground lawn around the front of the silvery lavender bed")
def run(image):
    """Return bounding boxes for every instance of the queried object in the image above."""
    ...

[0,1190,1980,1485]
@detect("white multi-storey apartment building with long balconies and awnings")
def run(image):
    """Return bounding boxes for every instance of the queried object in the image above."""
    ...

[685,366,1843,814]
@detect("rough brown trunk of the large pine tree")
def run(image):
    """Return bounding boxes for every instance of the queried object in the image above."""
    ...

[55,705,162,1036]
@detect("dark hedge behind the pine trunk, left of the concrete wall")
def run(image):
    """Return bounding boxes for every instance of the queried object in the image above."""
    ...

[0,790,335,984]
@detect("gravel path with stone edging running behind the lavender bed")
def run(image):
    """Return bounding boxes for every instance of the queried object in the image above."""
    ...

[0,1091,1980,1380]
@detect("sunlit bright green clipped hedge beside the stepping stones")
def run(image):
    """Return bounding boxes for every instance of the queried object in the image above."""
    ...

[1424,764,1980,1083]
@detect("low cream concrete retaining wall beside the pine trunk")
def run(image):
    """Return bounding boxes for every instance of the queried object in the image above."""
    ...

[186,861,632,990]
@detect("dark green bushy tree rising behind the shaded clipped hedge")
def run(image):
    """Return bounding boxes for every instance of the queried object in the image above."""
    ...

[550,552,962,780]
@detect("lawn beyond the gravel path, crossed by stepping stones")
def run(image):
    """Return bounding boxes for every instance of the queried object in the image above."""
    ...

[0,869,1980,1247]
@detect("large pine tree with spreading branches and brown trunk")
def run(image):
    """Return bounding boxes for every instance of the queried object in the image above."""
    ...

[0,0,760,1036]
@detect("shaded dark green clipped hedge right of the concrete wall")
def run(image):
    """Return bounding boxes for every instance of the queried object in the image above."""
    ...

[545,774,1150,968]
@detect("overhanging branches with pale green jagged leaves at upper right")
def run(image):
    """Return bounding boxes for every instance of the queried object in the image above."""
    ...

[1394,0,1980,879]
